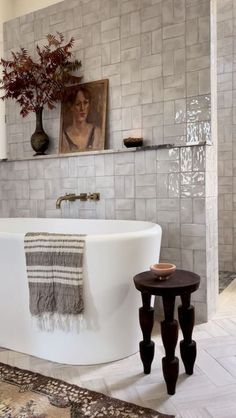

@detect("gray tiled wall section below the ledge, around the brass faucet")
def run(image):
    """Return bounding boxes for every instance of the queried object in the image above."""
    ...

[0,146,206,319]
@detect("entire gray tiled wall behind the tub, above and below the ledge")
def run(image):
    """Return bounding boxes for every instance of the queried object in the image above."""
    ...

[0,0,216,320]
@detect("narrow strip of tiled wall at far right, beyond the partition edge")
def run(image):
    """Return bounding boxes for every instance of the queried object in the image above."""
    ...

[217,0,236,271]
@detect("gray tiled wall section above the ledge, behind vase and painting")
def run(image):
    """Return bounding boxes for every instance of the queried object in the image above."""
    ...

[4,0,211,159]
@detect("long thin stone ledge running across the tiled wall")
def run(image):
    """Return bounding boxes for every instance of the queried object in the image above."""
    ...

[0,142,209,162]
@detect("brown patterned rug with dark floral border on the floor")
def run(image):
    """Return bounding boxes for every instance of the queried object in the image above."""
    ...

[0,363,173,418]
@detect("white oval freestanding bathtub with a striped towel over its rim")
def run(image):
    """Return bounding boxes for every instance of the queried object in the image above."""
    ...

[0,218,161,364]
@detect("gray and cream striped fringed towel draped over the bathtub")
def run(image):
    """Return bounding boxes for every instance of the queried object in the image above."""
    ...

[24,232,85,317]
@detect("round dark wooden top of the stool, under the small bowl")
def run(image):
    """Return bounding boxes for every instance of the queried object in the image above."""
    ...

[134,270,200,296]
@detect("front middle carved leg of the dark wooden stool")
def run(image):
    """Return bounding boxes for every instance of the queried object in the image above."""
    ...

[161,296,179,395]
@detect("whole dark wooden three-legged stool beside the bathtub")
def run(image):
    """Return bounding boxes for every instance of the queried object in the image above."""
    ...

[134,270,200,395]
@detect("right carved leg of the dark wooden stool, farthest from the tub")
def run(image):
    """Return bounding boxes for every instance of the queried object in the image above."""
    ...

[178,294,197,375]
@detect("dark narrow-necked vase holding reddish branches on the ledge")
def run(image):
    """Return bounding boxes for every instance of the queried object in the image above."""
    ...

[31,107,49,156]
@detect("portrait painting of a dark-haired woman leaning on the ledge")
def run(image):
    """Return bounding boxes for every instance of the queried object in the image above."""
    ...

[59,80,108,154]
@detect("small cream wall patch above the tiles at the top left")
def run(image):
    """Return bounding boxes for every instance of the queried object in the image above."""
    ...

[10,0,60,18]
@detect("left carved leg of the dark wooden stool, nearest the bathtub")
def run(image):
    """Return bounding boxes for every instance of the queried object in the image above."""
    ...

[139,293,155,374]
